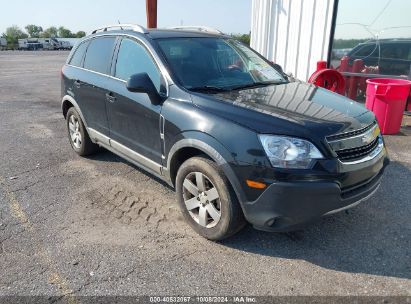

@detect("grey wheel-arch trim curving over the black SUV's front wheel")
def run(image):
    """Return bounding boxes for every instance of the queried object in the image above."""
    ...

[167,131,246,206]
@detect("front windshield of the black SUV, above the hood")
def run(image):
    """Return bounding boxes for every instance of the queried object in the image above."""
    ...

[158,38,286,90]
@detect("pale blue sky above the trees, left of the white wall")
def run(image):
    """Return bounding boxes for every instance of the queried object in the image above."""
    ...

[0,0,251,33]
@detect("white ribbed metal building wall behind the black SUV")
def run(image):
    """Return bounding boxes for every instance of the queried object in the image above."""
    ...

[251,0,334,80]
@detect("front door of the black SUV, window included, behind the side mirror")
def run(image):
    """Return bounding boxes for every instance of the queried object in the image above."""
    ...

[107,38,167,169]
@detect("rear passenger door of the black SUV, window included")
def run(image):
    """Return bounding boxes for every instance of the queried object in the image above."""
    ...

[76,36,116,136]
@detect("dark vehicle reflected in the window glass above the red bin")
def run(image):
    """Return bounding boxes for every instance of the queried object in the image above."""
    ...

[347,39,411,76]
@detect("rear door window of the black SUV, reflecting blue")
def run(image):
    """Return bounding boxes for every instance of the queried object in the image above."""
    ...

[84,37,115,74]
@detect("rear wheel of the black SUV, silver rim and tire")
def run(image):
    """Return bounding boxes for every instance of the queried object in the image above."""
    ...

[66,107,98,156]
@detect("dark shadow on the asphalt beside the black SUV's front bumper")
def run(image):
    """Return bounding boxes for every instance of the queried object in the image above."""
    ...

[221,162,411,279]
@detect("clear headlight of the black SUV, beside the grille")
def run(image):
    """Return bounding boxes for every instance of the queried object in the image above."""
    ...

[258,135,324,169]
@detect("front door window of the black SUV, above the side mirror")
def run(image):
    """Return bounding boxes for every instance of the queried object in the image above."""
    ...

[115,39,161,90]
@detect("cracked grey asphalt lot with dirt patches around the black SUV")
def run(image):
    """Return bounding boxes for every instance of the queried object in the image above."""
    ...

[0,52,411,298]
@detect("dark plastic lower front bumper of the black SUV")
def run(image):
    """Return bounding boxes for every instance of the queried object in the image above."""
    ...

[243,158,389,232]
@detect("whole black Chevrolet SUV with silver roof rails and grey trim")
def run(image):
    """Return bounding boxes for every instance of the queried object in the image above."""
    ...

[62,25,388,240]
